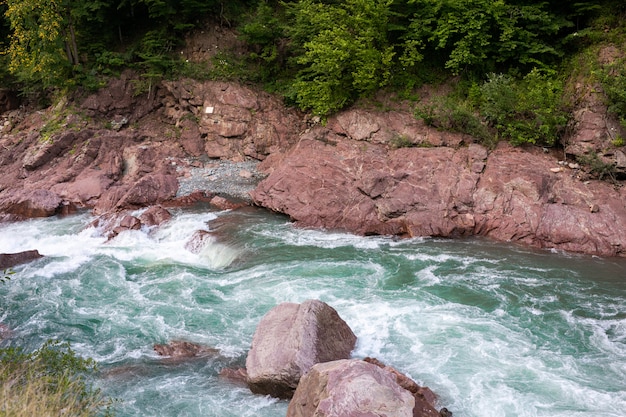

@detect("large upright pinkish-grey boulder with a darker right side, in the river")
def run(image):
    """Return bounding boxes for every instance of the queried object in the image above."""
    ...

[246,300,356,398]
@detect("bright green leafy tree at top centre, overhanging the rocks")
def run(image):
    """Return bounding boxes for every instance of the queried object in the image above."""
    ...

[287,0,394,116]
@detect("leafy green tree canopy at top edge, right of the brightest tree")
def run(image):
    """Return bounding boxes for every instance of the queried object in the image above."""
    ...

[404,0,573,73]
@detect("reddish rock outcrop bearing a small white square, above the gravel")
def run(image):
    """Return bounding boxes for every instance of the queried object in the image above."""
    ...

[163,80,303,160]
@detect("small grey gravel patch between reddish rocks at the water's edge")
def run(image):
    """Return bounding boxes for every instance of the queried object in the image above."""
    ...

[176,160,266,203]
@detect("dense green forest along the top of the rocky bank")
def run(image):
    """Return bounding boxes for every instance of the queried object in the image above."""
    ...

[0,0,626,146]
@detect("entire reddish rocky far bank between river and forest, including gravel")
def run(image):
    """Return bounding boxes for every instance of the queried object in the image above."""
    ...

[0,74,626,256]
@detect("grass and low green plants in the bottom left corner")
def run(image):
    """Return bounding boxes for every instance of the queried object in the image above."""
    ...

[0,341,112,417]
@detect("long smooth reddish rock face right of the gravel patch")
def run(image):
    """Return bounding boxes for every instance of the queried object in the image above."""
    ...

[252,134,626,256]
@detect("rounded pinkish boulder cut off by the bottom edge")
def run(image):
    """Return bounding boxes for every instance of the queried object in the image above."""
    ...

[287,359,420,417]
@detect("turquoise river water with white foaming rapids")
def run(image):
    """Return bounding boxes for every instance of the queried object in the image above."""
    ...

[0,209,626,417]
